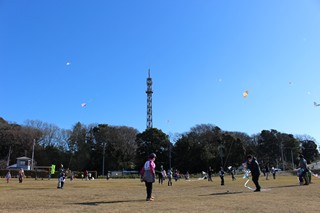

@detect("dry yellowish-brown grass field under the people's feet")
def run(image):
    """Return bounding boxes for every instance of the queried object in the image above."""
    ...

[0,175,320,213]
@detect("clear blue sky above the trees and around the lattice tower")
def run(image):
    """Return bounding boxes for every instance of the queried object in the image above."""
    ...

[0,0,320,142]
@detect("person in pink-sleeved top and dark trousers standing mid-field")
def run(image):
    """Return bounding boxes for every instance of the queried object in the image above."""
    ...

[141,153,157,201]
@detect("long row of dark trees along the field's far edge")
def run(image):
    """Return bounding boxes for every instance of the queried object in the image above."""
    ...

[0,117,319,175]
